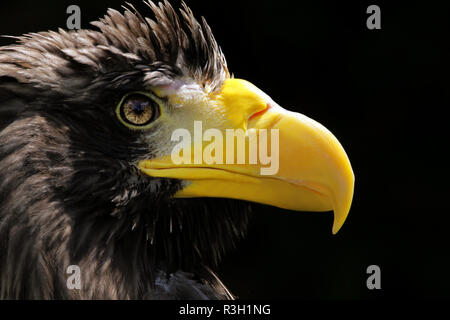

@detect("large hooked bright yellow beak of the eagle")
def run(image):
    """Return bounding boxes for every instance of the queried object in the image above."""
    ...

[139,79,355,234]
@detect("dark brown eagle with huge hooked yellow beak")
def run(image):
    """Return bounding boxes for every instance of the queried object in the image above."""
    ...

[0,1,354,299]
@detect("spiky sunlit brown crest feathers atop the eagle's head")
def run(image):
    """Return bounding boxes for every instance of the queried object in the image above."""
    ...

[0,1,229,94]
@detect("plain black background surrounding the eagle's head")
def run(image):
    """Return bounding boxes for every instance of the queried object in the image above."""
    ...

[0,0,450,299]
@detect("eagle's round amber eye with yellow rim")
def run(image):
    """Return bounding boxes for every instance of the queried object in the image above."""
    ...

[116,92,160,130]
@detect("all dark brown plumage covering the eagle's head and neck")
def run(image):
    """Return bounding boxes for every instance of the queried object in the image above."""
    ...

[0,2,248,299]
